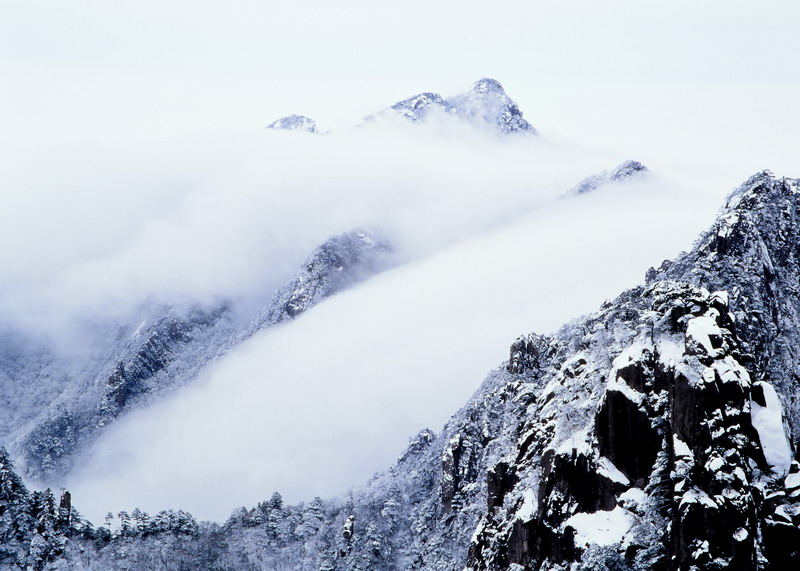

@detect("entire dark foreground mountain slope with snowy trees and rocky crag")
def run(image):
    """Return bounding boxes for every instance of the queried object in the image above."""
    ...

[0,168,800,570]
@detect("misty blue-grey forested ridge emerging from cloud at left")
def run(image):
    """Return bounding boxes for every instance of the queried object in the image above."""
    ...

[0,231,391,480]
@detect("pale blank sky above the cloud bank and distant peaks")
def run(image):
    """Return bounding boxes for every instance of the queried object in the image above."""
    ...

[0,0,800,148]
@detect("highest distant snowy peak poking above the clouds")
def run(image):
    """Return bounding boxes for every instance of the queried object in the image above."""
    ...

[391,78,537,134]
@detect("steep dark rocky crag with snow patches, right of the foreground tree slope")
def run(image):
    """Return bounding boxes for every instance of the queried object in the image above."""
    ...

[468,173,800,570]
